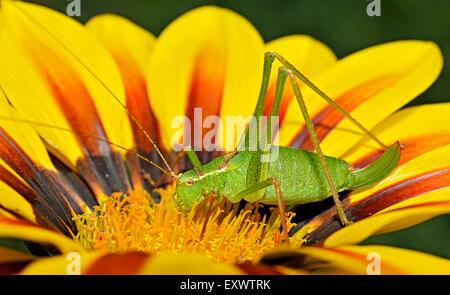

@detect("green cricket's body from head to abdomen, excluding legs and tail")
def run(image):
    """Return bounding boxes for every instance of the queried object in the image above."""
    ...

[177,147,349,209]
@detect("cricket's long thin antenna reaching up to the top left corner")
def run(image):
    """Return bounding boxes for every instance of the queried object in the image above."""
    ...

[12,2,178,180]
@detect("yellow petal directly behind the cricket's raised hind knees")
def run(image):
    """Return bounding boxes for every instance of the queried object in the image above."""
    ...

[264,35,337,122]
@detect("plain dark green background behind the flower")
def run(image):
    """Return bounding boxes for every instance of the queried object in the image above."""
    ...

[24,0,450,258]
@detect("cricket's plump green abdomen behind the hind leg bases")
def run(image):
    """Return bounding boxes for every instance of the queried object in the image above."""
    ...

[229,147,349,205]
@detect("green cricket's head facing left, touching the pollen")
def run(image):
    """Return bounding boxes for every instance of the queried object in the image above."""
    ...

[173,170,205,212]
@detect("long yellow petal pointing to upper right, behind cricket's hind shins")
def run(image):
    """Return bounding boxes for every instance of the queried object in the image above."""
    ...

[280,41,443,157]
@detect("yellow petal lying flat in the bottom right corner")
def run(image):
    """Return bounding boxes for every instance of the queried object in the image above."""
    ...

[299,245,450,274]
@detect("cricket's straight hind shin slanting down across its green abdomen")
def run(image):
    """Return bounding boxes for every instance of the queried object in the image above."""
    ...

[289,74,350,225]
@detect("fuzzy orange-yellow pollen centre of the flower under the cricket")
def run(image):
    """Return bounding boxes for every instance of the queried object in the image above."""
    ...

[75,186,301,263]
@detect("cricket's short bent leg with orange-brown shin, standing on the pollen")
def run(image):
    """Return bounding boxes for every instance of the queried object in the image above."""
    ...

[236,177,289,245]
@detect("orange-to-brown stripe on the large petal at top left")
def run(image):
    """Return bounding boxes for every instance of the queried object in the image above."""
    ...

[24,39,129,195]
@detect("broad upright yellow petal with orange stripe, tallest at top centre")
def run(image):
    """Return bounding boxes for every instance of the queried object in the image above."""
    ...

[147,6,264,148]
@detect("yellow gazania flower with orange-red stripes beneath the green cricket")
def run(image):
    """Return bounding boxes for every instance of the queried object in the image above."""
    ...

[0,1,450,274]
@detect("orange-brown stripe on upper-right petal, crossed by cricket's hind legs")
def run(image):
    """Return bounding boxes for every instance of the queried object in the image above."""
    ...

[290,75,399,150]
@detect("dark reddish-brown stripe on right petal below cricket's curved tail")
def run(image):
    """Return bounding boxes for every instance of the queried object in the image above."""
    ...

[306,168,450,245]
